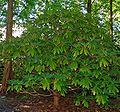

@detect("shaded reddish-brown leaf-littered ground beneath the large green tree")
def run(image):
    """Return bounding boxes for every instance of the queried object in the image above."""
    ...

[0,94,120,112]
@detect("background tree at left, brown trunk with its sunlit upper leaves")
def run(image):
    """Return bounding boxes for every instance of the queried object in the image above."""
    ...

[0,0,43,91]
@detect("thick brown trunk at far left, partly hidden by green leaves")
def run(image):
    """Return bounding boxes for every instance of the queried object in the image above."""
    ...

[2,0,13,92]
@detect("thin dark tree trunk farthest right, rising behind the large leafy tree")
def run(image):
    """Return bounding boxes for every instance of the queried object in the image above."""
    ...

[110,0,113,38]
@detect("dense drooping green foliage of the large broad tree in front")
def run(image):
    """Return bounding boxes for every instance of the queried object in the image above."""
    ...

[0,2,120,107]
